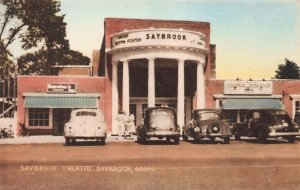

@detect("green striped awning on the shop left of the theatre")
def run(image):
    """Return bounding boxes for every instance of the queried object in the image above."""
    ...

[25,96,97,108]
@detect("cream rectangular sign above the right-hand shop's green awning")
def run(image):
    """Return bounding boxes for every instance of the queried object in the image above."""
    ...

[224,81,273,95]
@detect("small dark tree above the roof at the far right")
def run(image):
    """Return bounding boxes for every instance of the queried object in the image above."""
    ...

[275,59,300,79]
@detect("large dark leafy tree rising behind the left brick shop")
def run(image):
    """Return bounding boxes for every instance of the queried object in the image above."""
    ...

[0,0,89,74]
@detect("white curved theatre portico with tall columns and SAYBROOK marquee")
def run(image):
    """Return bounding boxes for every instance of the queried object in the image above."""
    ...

[108,29,207,133]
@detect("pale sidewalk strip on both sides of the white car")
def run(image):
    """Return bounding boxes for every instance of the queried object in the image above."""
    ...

[0,135,136,145]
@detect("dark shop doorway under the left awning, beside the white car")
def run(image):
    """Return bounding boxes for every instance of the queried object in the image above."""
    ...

[52,108,71,136]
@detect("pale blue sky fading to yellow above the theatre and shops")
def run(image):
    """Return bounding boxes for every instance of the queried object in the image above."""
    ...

[61,0,300,80]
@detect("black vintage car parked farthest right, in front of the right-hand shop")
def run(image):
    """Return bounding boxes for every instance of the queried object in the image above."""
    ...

[232,110,300,143]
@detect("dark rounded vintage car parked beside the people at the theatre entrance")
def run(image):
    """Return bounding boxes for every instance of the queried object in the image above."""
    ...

[137,107,180,144]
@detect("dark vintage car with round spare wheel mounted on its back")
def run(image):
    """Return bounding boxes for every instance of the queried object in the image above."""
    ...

[182,109,232,144]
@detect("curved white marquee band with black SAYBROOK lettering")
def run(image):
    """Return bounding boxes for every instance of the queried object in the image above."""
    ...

[112,29,205,49]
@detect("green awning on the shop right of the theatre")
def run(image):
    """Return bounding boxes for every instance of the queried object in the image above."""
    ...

[221,98,284,110]
